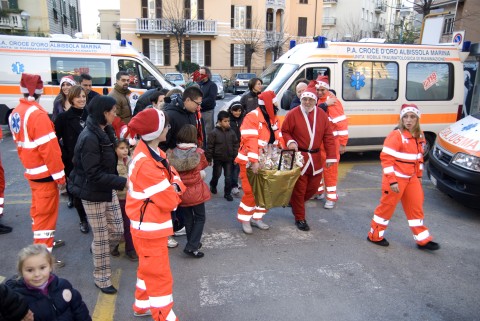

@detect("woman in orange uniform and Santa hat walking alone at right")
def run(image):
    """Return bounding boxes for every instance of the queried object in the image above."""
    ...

[367,104,440,251]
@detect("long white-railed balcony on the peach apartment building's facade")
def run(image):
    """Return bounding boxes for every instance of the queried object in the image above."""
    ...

[135,18,218,36]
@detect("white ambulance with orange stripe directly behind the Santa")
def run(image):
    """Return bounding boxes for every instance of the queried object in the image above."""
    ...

[255,37,468,155]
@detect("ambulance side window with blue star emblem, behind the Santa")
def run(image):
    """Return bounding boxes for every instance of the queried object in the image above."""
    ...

[342,61,398,101]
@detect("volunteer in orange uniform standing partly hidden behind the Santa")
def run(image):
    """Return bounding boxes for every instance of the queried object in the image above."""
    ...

[315,76,348,208]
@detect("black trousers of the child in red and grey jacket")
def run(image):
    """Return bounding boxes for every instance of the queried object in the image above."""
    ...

[177,203,205,251]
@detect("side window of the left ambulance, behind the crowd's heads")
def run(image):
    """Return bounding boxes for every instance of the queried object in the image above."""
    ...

[50,57,112,86]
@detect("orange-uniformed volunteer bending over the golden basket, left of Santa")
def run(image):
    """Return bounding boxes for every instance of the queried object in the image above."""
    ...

[235,91,283,234]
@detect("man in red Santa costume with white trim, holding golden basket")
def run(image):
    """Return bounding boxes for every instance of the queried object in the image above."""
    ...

[282,81,337,231]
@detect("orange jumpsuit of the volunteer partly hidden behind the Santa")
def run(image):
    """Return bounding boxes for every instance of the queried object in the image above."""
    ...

[317,92,348,202]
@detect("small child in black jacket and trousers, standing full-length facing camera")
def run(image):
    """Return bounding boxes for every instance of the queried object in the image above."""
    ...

[205,110,239,202]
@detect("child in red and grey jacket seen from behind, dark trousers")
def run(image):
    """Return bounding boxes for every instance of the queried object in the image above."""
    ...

[167,124,210,258]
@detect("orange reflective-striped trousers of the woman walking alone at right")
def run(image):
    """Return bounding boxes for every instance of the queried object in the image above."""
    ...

[368,176,432,245]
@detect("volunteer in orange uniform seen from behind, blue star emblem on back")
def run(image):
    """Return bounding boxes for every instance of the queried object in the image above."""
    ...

[9,74,65,252]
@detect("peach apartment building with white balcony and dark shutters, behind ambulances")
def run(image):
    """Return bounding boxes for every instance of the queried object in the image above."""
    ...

[120,0,323,77]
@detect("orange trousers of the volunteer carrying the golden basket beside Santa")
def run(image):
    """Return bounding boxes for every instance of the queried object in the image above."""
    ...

[237,164,267,222]
